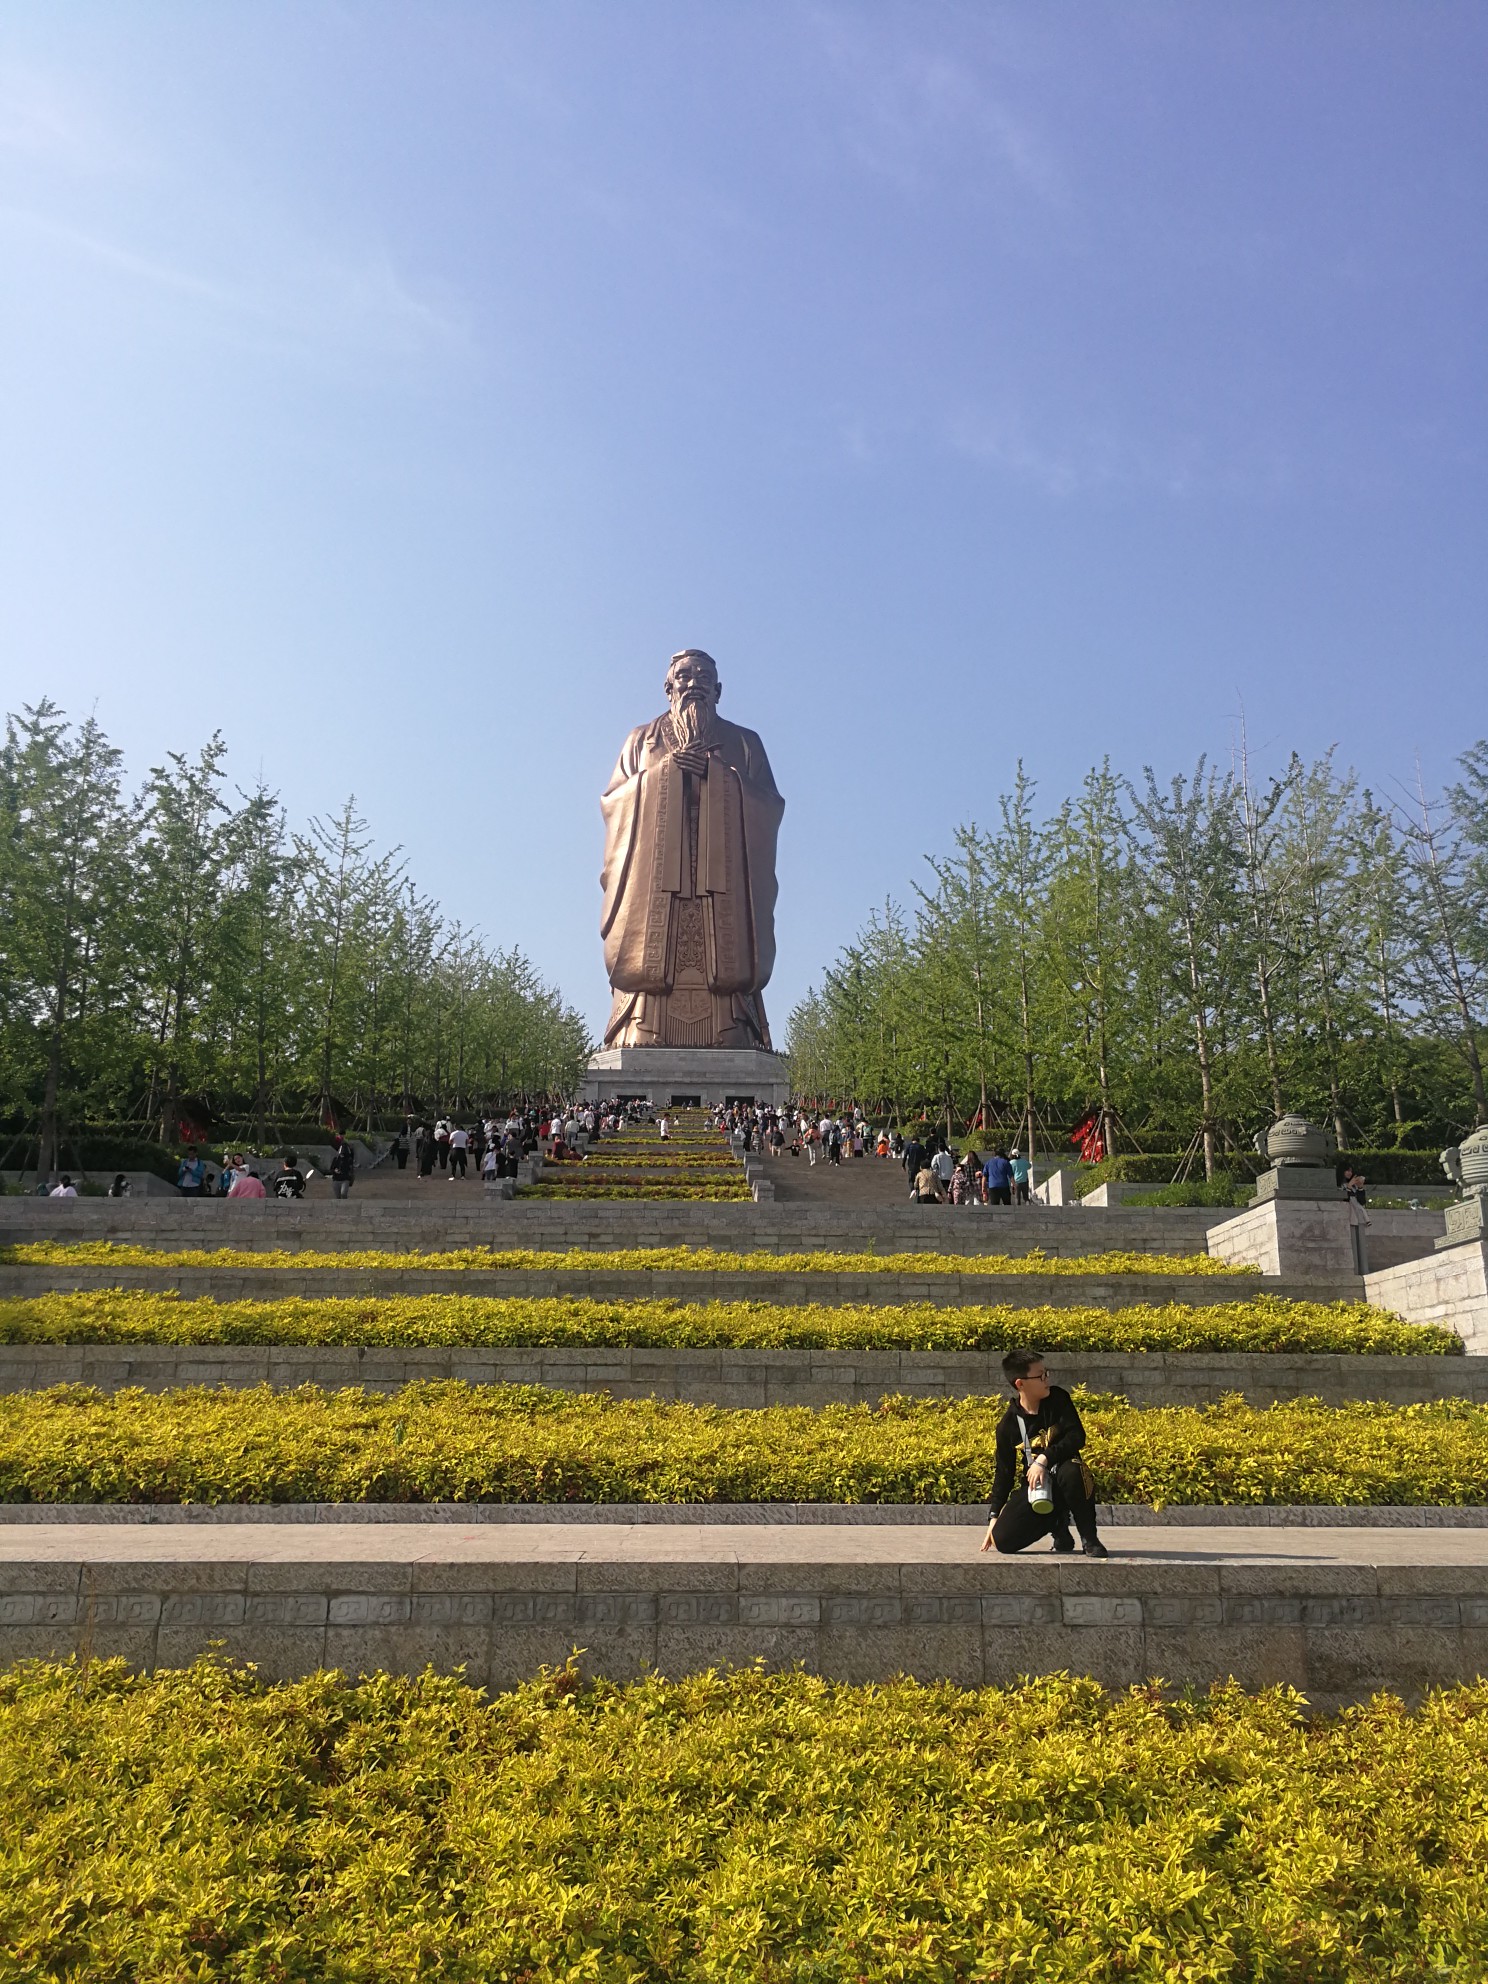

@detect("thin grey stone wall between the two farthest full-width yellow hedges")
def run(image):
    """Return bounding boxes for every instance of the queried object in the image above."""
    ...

[0,1264,1341,1309]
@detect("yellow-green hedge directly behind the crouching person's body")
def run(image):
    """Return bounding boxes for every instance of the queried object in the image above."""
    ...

[0,1361,1488,1506]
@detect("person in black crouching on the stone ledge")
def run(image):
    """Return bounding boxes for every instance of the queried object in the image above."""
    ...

[982,1351,1107,1557]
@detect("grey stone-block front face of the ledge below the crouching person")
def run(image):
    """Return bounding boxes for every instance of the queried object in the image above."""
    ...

[0,1557,1488,1708]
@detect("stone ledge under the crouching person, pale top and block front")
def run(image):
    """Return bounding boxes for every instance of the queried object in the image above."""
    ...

[0,1522,1488,1708]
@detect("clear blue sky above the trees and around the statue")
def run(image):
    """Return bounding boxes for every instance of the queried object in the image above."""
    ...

[0,0,1488,1032]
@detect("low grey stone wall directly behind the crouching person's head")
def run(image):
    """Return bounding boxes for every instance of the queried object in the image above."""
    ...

[0,1343,1488,1409]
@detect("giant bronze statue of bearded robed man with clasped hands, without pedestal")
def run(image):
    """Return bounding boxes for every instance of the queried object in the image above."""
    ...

[599,647,786,1048]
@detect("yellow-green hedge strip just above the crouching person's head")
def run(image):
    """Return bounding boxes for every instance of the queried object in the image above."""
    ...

[0,1288,1462,1357]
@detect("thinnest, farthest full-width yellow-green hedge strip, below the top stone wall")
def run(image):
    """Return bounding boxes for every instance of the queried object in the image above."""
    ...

[0,1245,1256,1290]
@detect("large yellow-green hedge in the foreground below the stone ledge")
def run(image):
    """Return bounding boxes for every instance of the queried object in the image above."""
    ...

[0,1661,1488,1984]
